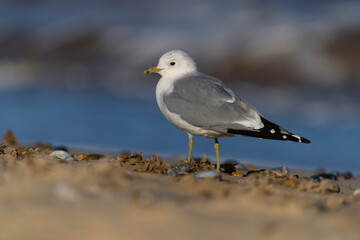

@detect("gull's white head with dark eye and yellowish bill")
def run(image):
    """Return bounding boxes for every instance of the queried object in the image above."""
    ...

[144,50,197,77]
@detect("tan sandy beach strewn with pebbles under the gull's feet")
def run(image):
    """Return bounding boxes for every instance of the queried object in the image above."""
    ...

[0,132,360,240]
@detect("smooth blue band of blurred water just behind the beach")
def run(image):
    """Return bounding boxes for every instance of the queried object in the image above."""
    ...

[0,90,360,173]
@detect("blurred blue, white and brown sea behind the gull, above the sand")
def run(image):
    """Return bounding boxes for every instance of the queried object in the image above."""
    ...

[0,0,360,173]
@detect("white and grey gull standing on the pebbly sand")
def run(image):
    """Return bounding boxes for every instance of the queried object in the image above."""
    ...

[144,50,310,170]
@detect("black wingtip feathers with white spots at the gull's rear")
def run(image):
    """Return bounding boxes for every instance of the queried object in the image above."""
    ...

[227,117,310,143]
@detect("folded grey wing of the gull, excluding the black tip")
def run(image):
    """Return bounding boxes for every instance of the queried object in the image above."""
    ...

[164,73,264,132]
